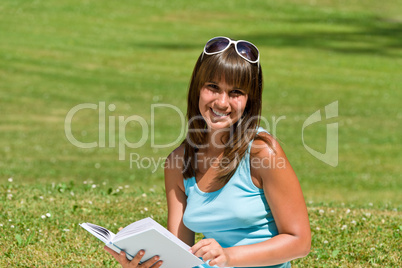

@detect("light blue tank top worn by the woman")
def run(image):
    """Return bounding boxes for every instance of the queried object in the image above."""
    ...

[183,129,290,268]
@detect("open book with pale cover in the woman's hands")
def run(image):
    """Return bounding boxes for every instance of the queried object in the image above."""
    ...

[80,218,204,268]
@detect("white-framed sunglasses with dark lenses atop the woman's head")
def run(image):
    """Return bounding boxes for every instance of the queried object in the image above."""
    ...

[203,36,260,63]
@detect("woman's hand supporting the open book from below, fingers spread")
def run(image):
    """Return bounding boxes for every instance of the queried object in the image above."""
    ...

[104,246,163,268]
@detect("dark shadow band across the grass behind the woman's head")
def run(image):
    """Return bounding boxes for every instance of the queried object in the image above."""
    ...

[132,17,402,57]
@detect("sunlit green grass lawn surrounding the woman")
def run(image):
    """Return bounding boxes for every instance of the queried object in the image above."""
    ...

[0,0,402,267]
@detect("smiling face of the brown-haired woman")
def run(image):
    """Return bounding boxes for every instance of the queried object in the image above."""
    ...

[199,79,248,130]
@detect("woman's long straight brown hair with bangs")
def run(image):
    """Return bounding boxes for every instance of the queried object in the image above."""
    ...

[183,46,271,183]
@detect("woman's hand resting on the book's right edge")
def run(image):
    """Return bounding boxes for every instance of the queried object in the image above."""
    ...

[190,239,229,267]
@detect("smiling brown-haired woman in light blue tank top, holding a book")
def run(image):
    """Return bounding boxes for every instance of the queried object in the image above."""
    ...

[104,37,311,268]
